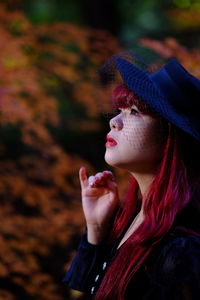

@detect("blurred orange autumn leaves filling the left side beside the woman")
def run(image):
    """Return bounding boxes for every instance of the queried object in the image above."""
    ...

[0,5,119,300]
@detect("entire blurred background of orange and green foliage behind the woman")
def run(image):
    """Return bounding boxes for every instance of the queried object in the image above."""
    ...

[0,0,200,300]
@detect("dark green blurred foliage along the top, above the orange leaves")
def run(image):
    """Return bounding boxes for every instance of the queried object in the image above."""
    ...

[1,0,200,50]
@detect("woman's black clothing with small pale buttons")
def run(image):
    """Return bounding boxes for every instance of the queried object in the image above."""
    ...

[64,205,200,300]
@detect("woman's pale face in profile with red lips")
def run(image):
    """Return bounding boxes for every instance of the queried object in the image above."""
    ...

[105,105,166,173]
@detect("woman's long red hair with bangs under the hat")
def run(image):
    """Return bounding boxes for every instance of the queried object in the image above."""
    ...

[95,85,199,300]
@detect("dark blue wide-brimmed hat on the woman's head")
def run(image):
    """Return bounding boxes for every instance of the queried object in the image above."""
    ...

[97,55,200,141]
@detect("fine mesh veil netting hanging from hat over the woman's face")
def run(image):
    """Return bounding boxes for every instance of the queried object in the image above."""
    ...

[94,51,167,164]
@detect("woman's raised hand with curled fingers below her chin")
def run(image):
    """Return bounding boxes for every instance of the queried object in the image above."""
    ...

[79,167,119,244]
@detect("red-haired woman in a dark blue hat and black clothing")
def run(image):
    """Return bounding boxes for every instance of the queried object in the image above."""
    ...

[64,55,200,300]
